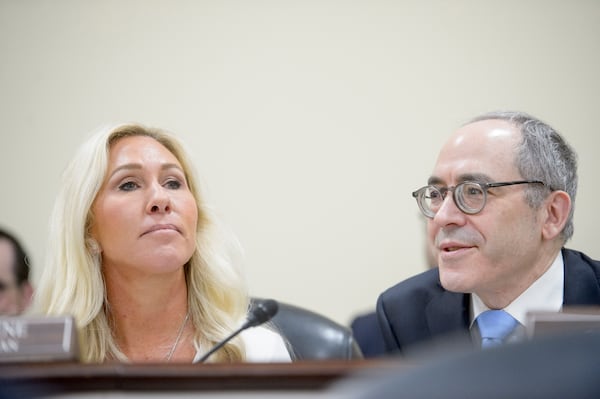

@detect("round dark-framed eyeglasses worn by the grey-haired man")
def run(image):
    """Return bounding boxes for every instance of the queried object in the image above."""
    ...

[412,180,545,219]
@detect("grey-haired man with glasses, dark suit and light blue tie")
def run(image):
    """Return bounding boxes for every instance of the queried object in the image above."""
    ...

[377,112,600,353]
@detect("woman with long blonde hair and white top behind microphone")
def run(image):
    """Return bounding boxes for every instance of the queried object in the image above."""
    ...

[35,124,290,363]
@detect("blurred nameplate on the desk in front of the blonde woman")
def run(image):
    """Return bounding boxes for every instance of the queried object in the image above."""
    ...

[0,316,79,363]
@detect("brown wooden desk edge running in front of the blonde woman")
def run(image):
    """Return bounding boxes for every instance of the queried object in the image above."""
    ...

[0,359,411,393]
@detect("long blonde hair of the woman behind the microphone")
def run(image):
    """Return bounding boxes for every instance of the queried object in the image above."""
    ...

[34,124,248,362]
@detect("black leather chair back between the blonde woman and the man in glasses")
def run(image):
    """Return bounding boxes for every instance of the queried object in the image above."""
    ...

[252,301,363,360]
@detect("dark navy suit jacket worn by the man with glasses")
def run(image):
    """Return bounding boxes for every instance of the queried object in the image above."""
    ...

[377,249,600,353]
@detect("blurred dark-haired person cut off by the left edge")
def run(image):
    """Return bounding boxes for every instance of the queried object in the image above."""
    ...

[0,228,33,316]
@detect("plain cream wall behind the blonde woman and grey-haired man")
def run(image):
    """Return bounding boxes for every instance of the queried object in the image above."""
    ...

[0,0,600,323]
